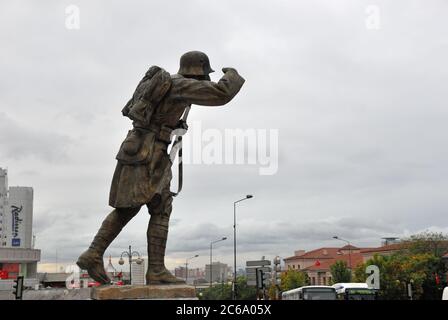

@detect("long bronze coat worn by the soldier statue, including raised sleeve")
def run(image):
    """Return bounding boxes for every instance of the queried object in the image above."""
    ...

[109,69,244,208]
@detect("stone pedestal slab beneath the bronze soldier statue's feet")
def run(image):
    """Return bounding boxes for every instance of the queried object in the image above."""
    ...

[91,284,196,300]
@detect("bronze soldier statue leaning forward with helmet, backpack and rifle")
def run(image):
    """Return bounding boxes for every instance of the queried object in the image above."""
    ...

[77,51,244,284]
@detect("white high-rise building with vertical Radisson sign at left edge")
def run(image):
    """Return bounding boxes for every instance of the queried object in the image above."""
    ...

[0,168,40,279]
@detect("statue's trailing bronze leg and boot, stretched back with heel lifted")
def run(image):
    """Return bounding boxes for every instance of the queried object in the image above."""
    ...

[76,208,140,284]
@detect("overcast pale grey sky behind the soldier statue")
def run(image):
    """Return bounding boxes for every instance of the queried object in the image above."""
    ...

[0,0,448,268]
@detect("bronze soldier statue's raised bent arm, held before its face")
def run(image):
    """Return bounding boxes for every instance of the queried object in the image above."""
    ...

[171,68,244,106]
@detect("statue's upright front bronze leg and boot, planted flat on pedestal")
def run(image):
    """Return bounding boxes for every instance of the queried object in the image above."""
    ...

[146,214,185,284]
